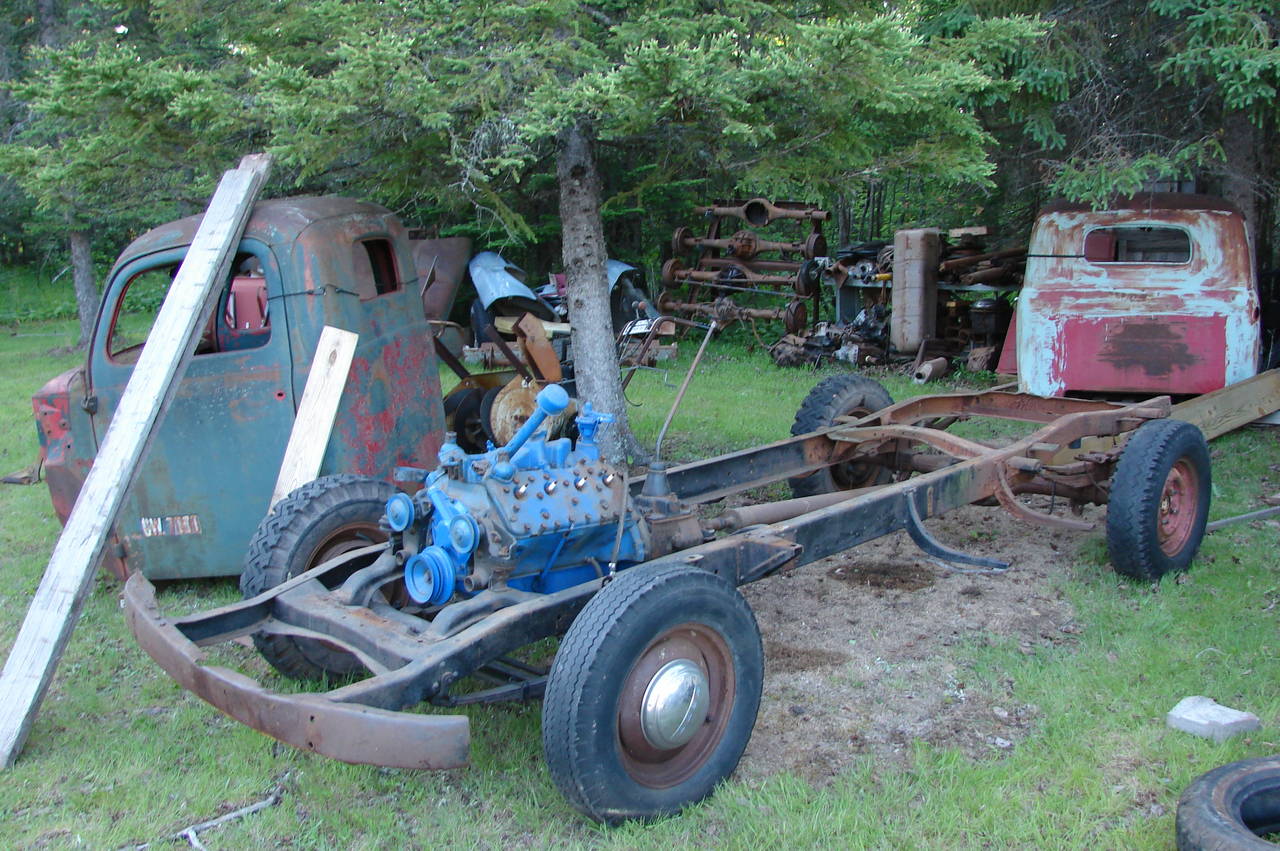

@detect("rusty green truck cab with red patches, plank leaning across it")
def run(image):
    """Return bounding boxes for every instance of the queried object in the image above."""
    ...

[32,197,444,578]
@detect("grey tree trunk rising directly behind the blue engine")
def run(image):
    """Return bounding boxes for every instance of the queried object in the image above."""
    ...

[556,122,640,463]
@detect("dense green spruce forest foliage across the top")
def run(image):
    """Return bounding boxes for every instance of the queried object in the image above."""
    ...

[0,0,1280,345]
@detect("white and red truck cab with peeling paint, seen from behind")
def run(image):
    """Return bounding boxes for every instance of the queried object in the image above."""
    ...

[1018,195,1261,397]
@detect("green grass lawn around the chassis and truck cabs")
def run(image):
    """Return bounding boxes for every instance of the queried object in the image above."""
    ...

[0,307,1280,851]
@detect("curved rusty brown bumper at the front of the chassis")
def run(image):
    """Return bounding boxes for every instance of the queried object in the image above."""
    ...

[124,573,471,769]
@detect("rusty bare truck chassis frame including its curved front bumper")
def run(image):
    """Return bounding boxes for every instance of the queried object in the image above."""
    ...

[124,392,1170,769]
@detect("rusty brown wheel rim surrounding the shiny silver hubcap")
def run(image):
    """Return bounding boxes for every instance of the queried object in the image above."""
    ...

[617,623,737,788]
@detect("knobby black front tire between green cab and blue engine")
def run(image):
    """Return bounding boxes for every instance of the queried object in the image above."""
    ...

[241,475,396,680]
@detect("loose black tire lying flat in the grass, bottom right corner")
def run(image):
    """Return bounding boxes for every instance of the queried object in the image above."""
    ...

[1176,756,1280,851]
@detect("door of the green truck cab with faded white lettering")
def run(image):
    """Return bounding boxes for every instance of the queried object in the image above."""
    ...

[90,239,294,578]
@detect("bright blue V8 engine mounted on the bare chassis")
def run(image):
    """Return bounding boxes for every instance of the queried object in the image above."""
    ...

[387,384,649,605]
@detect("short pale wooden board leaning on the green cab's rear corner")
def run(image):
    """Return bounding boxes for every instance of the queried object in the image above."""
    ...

[266,325,360,512]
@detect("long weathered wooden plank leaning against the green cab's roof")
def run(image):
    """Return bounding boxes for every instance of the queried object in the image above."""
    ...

[0,154,271,768]
